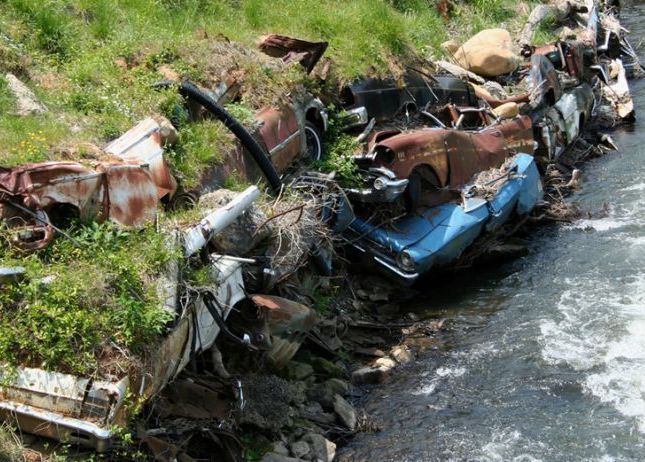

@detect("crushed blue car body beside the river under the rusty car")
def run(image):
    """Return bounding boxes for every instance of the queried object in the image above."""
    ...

[347,154,543,283]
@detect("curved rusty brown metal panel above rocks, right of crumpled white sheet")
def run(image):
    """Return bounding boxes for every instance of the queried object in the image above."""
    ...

[251,295,318,368]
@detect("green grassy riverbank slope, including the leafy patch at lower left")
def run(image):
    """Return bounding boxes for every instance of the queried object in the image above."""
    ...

[0,0,528,373]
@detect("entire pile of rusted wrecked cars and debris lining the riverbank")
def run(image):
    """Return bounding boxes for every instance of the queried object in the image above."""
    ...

[0,0,642,450]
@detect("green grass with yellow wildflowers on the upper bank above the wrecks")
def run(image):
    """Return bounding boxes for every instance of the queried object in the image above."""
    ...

[0,0,524,179]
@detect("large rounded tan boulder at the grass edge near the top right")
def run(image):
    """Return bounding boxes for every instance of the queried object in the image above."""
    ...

[455,29,521,77]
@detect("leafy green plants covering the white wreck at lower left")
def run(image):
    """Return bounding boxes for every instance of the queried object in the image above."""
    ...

[0,223,176,374]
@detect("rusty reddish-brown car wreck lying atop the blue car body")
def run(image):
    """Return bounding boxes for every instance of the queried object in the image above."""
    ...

[350,105,534,208]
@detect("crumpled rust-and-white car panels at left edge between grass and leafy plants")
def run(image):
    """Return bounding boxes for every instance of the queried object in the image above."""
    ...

[0,119,177,251]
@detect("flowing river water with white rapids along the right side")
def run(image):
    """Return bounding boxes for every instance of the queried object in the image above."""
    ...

[341,2,645,461]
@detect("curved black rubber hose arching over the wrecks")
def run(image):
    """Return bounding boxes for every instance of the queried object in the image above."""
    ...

[155,80,282,192]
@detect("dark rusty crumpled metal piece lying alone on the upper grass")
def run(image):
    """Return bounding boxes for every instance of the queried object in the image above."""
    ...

[258,34,329,73]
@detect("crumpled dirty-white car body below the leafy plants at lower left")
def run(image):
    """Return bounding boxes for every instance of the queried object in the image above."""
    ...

[0,257,246,452]
